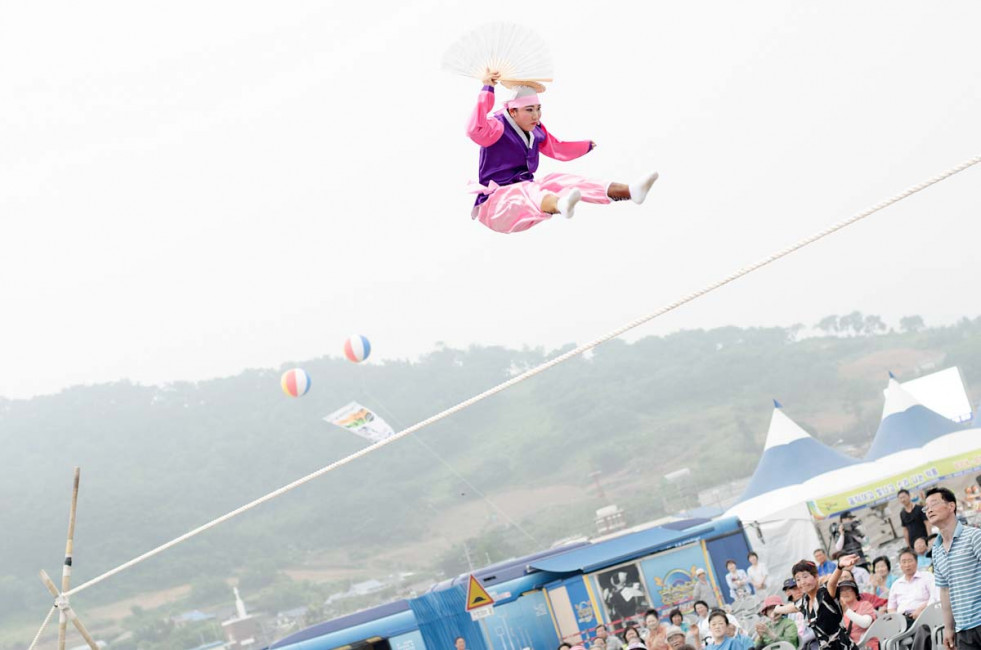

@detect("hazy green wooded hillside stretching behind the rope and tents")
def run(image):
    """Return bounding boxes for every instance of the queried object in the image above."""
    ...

[0,312,981,641]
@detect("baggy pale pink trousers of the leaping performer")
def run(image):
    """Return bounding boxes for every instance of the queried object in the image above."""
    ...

[475,174,610,234]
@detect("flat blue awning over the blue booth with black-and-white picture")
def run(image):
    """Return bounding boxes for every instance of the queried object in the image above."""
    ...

[531,517,739,573]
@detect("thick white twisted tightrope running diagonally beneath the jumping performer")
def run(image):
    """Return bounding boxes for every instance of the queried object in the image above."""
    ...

[64,156,981,596]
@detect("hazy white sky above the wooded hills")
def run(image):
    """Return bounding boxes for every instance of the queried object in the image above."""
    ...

[0,0,981,397]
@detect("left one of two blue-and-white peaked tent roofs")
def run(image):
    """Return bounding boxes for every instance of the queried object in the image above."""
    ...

[739,401,857,501]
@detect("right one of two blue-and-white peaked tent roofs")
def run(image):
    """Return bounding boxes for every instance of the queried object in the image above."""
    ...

[865,373,962,460]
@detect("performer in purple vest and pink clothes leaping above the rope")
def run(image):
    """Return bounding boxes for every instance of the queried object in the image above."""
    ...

[467,69,657,233]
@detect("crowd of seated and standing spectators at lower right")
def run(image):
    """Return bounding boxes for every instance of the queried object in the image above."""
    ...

[560,480,981,650]
